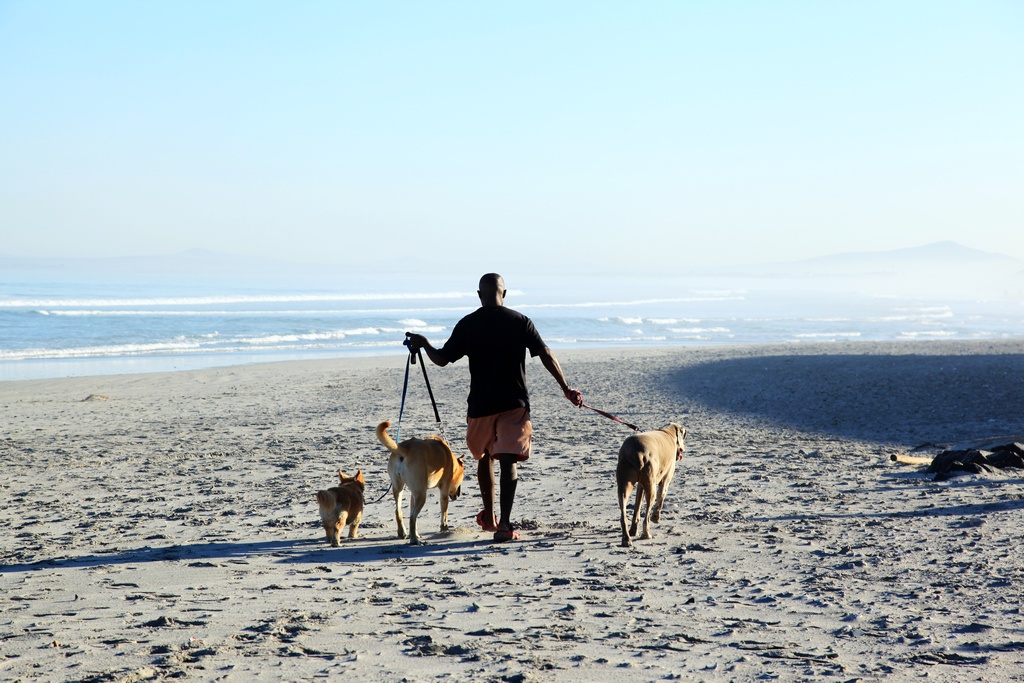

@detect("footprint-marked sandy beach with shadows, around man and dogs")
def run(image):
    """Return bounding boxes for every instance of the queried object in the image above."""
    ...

[0,341,1024,682]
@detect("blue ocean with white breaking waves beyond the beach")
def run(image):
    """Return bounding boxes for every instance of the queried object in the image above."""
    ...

[0,270,1024,381]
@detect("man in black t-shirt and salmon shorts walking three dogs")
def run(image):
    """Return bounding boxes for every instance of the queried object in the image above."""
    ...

[406,272,583,541]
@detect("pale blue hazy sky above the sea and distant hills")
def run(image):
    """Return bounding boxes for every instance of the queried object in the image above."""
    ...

[0,0,1024,271]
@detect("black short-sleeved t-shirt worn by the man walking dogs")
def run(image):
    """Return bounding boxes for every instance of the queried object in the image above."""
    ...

[438,306,545,418]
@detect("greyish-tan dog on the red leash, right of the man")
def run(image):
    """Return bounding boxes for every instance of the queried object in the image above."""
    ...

[615,422,686,548]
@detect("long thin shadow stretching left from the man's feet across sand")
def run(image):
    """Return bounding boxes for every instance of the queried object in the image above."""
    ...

[0,533,503,574]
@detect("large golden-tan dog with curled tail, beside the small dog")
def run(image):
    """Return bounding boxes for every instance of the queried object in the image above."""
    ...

[377,422,465,546]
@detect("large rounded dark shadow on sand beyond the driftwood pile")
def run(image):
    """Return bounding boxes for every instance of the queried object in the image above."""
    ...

[670,352,1024,445]
